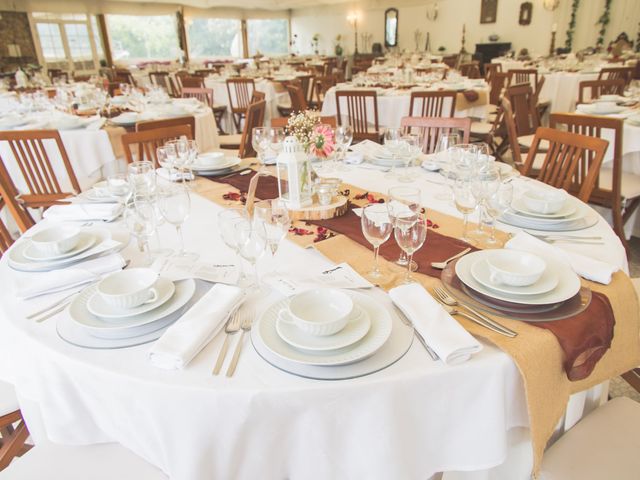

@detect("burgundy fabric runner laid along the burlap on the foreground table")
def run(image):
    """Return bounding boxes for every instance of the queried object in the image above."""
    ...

[210,173,615,381]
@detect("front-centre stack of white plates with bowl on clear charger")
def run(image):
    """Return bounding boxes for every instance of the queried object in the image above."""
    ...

[251,289,411,379]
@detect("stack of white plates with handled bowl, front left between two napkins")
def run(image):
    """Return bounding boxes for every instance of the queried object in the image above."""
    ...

[58,268,196,348]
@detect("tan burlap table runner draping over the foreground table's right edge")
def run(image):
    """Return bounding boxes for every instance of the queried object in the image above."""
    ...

[196,174,640,472]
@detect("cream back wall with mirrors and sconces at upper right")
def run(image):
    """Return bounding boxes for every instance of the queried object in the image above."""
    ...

[291,0,640,55]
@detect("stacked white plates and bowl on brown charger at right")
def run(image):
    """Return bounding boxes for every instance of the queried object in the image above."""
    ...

[442,249,591,322]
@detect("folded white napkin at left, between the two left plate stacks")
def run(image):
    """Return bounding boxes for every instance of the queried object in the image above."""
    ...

[13,253,125,300]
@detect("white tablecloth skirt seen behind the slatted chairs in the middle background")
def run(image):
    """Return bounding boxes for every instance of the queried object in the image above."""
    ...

[322,88,487,128]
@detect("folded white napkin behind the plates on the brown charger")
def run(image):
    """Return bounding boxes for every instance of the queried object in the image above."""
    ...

[504,232,619,285]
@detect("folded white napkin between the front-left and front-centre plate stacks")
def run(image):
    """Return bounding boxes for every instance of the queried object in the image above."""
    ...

[149,283,243,370]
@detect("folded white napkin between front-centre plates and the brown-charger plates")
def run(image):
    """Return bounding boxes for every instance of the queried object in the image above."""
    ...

[389,283,482,365]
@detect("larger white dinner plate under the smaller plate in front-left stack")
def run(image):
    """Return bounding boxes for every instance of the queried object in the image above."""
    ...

[69,279,196,339]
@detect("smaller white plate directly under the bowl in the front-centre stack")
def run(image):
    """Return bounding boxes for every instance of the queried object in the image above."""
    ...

[276,306,371,352]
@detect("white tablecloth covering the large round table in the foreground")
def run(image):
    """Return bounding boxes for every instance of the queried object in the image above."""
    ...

[0,168,626,480]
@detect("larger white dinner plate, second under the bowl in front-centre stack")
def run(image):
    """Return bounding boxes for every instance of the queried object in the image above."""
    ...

[253,292,392,366]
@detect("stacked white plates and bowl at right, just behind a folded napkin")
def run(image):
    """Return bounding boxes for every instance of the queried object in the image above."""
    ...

[500,188,598,232]
